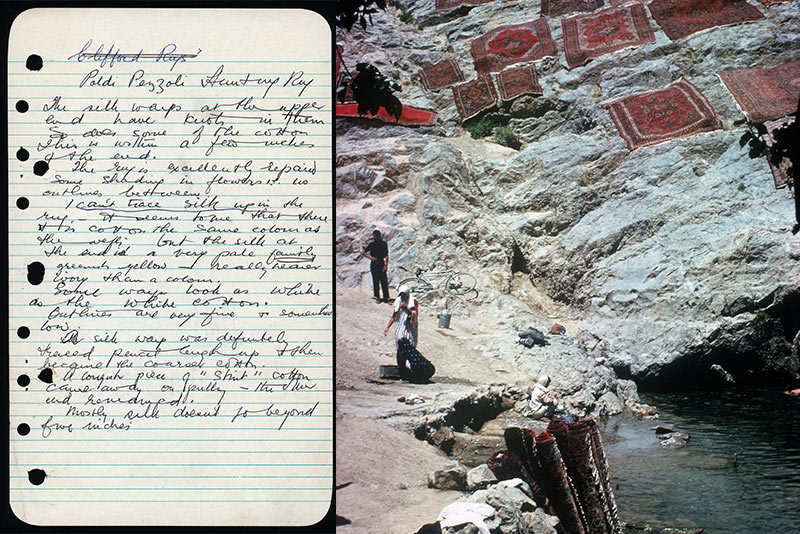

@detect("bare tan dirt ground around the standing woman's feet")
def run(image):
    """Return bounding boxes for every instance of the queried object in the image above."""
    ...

[336,288,530,534]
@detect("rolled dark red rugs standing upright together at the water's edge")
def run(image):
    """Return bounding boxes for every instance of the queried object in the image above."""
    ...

[488,420,622,534]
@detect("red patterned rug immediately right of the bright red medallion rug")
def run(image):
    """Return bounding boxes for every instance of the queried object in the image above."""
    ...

[561,4,656,68]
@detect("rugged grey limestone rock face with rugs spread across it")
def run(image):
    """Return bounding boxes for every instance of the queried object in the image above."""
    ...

[336,0,800,394]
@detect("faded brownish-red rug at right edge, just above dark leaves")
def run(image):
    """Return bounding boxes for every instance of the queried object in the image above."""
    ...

[718,60,800,122]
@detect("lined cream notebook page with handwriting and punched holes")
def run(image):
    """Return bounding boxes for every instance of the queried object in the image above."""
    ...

[8,9,333,525]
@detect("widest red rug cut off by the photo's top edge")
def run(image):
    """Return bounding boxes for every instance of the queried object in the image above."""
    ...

[647,0,764,41]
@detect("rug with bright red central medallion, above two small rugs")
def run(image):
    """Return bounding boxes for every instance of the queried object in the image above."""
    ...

[471,17,558,75]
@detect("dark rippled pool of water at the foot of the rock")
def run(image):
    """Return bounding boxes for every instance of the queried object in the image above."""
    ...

[601,389,800,534]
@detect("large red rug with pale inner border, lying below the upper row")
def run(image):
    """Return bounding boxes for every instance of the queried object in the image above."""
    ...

[602,78,722,150]
